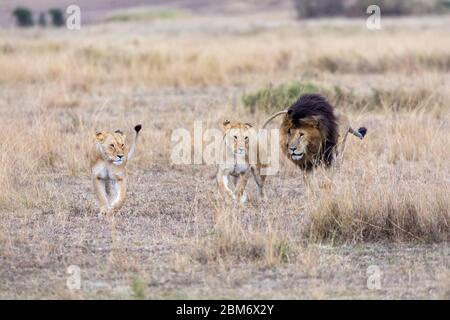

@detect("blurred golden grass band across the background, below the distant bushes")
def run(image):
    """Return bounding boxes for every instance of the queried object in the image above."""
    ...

[0,31,450,87]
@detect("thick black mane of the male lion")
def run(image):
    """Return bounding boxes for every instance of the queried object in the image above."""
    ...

[286,94,338,166]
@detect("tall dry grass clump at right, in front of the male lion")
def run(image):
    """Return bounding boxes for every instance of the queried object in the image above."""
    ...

[304,170,450,243]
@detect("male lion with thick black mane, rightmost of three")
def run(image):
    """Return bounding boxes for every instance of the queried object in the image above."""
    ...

[263,94,367,172]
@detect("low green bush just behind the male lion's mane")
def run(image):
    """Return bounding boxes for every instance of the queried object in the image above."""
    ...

[242,81,320,113]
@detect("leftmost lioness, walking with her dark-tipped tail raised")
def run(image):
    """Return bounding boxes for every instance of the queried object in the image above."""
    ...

[90,124,142,213]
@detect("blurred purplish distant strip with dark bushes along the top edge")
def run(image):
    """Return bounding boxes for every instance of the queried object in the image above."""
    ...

[0,0,450,26]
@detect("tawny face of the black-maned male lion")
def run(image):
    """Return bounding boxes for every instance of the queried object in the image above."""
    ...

[285,126,322,161]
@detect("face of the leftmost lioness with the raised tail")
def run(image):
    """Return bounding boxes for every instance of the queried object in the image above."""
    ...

[95,130,127,166]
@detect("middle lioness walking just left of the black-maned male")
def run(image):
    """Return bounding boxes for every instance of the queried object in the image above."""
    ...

[216,120,264,204]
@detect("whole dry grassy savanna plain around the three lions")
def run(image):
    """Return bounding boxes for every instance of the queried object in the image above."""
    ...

[0,5,450,299]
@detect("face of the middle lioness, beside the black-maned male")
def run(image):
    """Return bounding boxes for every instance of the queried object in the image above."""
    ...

[223,120,252,156]
